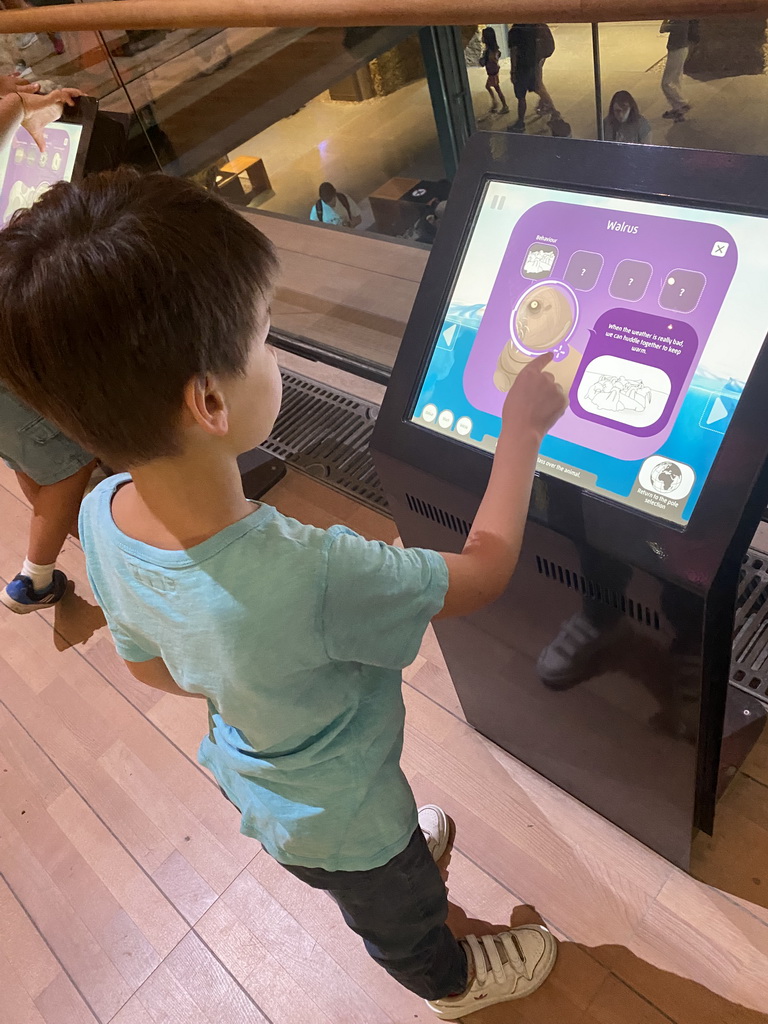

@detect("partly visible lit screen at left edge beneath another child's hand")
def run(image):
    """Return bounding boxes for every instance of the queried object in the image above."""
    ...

[0,121,83,227]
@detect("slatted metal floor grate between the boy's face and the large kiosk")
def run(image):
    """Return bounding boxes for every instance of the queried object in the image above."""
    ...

[261,370,389,515]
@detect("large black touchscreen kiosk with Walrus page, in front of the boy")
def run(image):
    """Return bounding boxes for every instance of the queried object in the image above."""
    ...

[373,133,768,866]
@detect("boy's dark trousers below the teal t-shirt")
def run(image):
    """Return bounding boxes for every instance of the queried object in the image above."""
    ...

[284,829,468,999]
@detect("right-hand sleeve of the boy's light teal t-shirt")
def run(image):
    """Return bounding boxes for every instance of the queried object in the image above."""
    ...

[321,531,449,670]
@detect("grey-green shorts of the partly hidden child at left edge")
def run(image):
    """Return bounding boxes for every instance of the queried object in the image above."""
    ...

[0,384,93,486]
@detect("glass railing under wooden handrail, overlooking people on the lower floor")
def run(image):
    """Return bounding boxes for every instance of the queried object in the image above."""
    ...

[0,14,768,376]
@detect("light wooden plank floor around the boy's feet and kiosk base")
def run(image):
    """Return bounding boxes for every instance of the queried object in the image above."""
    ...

[0,470,768,1024]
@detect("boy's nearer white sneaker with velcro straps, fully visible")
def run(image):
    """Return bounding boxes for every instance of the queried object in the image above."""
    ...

[427,925,557,1021]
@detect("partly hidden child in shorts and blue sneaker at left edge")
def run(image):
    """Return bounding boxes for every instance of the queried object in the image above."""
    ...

[0,75,95,614]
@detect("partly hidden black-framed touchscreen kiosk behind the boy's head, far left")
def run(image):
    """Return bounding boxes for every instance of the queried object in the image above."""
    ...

[0,96,98,228]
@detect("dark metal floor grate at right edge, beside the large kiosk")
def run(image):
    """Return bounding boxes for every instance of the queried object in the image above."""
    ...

[731,551,768,705]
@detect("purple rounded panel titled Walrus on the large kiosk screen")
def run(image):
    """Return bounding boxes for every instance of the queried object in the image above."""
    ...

[464,202,737,460]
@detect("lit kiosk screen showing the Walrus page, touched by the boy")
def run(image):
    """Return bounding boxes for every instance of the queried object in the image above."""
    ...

[412,180,768,524]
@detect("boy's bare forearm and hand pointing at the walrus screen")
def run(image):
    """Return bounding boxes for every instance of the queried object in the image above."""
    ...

[435,354,566,618]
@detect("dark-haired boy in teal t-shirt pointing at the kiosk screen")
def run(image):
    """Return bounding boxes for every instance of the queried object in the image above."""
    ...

[0,171,565,1020]
